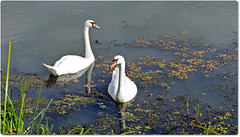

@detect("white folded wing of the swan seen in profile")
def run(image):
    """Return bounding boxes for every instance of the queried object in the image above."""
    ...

[54,55,93,75]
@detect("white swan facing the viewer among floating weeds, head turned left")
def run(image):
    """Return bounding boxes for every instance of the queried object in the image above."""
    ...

[108,55,137,102]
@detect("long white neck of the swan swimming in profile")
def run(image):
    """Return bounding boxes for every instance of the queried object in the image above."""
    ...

[84,27,94,60]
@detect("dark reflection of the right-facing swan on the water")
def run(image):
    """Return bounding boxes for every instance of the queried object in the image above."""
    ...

[46,62,95,94]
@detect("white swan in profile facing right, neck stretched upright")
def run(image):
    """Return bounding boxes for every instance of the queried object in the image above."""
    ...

[43,20,100,76]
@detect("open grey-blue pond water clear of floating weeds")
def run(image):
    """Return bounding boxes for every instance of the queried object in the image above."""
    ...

[1,1,238,134]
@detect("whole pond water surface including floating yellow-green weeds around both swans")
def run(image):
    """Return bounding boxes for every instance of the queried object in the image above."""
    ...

[1,2,238,134]
